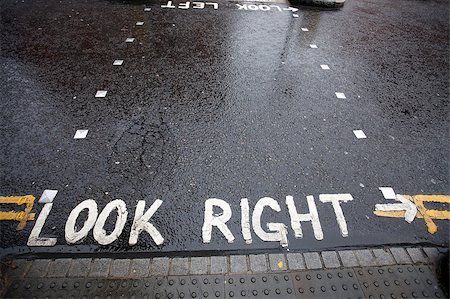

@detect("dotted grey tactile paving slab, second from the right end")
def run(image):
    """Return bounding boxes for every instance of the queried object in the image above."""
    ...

[292,269,364,298]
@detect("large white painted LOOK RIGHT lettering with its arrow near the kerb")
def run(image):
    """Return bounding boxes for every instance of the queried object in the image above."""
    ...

[27,192,442,247]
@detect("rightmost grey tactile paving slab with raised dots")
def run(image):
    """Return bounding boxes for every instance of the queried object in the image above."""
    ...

[355,265,445,298]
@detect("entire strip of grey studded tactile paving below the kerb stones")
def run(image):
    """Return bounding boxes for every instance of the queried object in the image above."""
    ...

[5,265,445,299]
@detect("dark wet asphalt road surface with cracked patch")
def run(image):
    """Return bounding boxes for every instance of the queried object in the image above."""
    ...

[0,0,449,254]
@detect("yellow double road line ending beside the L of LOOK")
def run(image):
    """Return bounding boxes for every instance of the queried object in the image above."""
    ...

[0,195,35,230]
